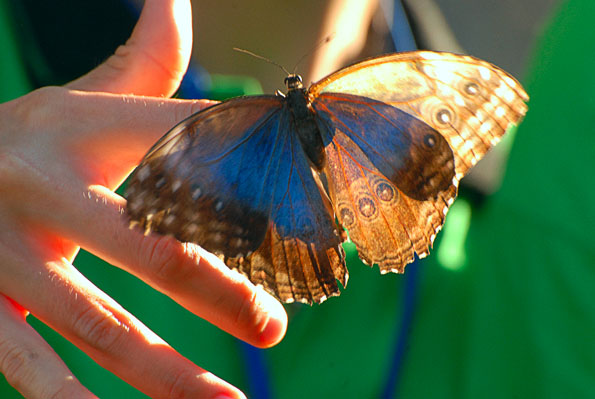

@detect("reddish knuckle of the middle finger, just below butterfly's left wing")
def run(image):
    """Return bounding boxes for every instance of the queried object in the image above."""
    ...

[139,236,191,287]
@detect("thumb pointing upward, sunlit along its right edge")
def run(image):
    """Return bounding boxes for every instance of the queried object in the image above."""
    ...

[67,0,192,97]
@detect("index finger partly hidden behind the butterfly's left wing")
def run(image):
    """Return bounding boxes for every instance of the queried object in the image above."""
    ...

[57,92,215,189]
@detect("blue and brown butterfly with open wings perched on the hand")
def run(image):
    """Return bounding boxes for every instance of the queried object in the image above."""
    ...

[126,51,529,303]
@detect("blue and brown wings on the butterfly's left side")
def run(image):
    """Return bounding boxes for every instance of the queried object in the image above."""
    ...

[127,96,347,302]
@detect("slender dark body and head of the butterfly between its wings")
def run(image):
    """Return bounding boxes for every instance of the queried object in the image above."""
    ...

[285,75,324,170]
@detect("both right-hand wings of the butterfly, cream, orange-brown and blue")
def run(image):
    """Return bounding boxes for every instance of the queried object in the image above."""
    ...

[309,51,528,272]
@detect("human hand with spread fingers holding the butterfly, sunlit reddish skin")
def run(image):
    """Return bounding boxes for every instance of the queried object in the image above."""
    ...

[0,0,287,398]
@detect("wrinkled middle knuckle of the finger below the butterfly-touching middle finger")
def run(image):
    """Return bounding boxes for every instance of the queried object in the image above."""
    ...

[72,301,130,354]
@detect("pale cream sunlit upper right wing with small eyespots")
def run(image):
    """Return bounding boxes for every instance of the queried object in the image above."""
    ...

[309,51,529,180]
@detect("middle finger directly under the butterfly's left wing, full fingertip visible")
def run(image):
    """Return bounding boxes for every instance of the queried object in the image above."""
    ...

[64,186,287,347]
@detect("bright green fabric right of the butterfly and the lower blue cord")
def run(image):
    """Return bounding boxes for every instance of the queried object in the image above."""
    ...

[400,0,595,398]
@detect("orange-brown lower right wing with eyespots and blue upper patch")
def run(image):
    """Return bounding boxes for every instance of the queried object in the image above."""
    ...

[313,93,456,272]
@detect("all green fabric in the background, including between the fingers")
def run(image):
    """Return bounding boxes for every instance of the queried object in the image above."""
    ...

[0,0,595,399]
